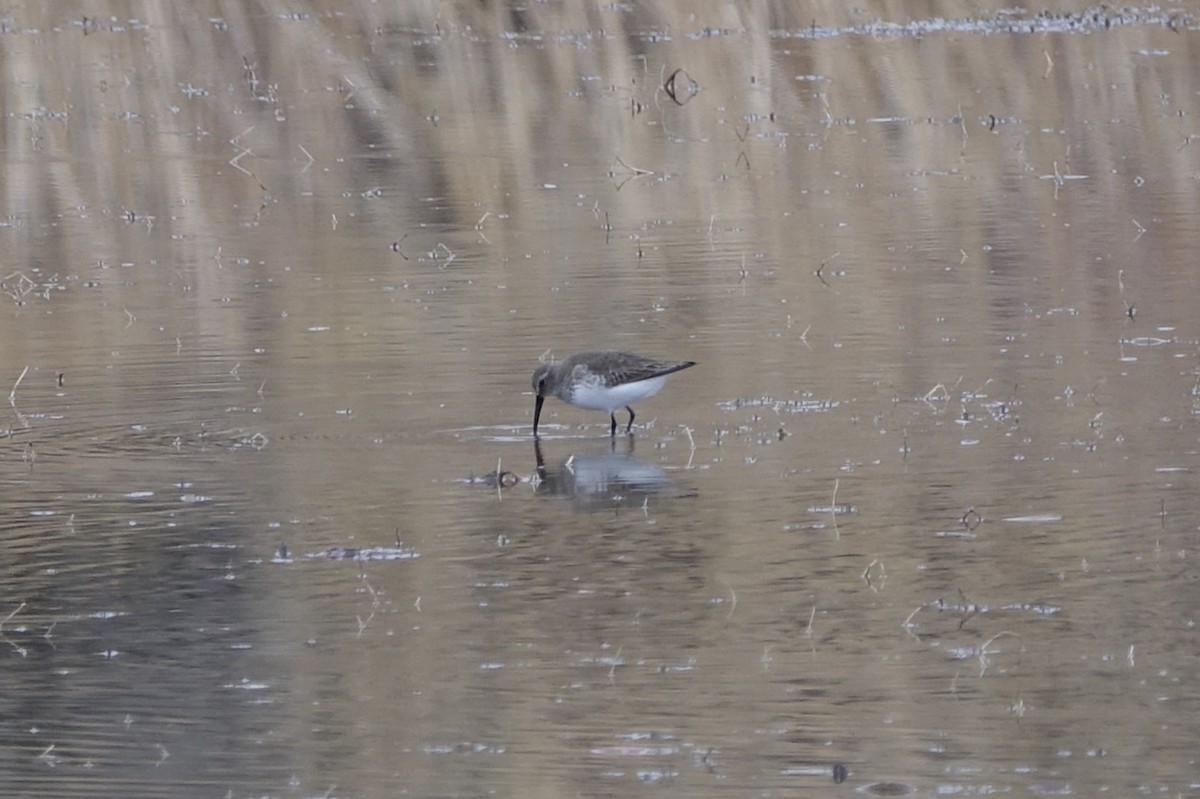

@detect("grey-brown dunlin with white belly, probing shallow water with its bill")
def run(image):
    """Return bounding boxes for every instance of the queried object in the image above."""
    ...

[533,350,696,435]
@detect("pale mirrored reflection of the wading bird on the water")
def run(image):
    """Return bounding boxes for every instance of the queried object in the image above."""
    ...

[533,437,671,507]
